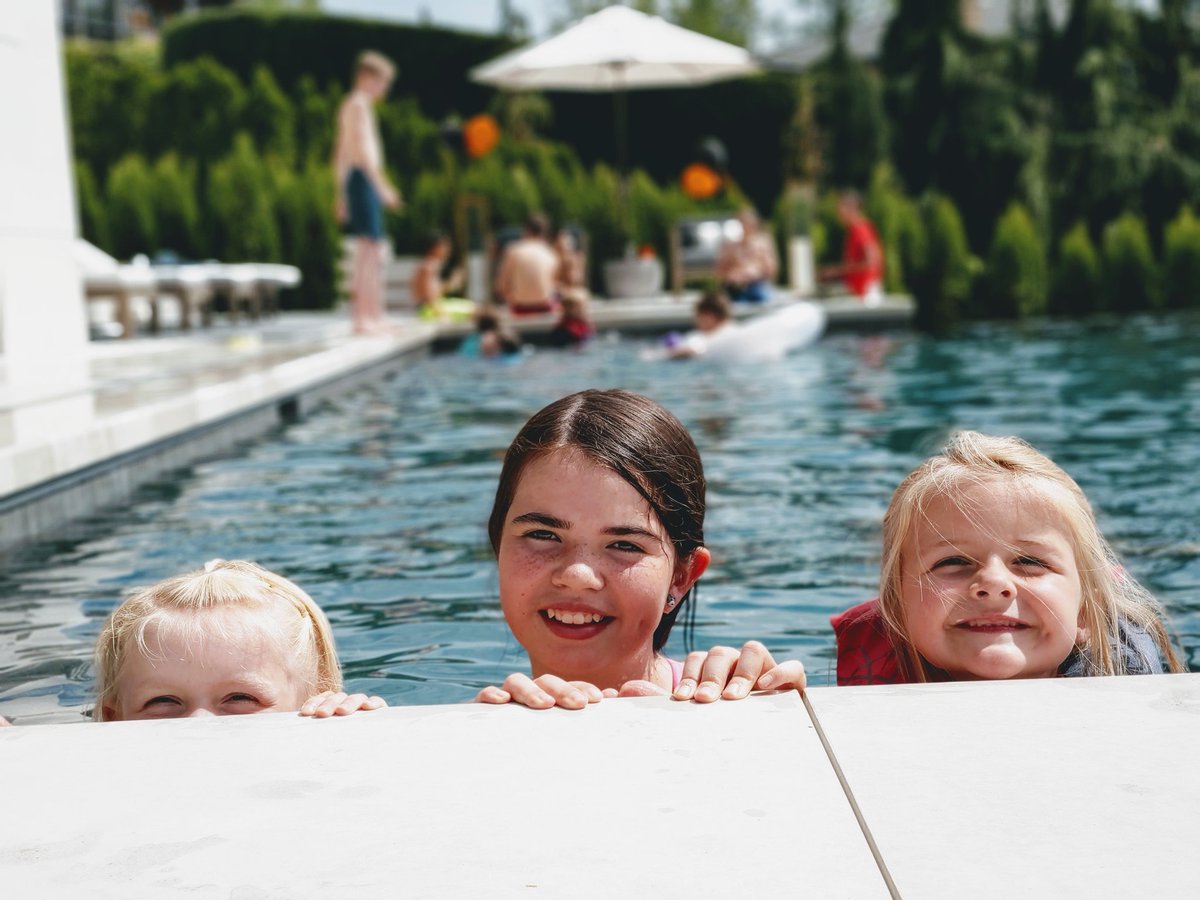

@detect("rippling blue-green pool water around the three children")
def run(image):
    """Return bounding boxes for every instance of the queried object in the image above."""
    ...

[0,316,1200,722]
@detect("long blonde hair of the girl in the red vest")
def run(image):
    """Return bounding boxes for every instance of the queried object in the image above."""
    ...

[880,431,1183,682]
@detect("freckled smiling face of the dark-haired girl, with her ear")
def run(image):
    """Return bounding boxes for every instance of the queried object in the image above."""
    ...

[498,449,709,688]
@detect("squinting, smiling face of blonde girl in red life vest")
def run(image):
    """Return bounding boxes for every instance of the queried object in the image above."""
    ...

[900,482,1084,679]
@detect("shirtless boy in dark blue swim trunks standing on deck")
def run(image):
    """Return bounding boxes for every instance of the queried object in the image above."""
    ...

[334,50,400,335]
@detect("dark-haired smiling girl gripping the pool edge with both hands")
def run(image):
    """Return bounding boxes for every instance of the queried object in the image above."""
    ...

[476,390,804,709]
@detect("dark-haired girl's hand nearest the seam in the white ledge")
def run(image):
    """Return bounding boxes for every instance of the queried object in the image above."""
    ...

[673,641,805,703]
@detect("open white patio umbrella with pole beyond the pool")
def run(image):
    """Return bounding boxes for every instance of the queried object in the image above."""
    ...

[470,6,758,172]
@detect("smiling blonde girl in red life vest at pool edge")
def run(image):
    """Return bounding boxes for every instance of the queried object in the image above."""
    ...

[833,432,1182,684]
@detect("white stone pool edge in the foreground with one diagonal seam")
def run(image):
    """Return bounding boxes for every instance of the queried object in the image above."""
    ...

[0,674,1200,900]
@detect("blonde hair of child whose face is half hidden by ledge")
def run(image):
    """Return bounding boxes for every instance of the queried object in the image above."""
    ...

[94,559,342,721]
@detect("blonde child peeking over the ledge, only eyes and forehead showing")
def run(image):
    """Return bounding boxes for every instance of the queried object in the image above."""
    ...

[95,559,386,721]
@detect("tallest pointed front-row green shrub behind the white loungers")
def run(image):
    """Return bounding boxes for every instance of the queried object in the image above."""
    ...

[209,133,280,263]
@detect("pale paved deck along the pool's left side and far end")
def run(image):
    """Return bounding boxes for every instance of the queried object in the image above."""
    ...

[0,294,913,552]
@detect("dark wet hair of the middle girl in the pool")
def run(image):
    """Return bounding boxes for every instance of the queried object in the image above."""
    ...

[487,390,706,652]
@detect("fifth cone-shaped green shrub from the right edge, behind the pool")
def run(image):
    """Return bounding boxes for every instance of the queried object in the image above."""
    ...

[911,193,979,330]
